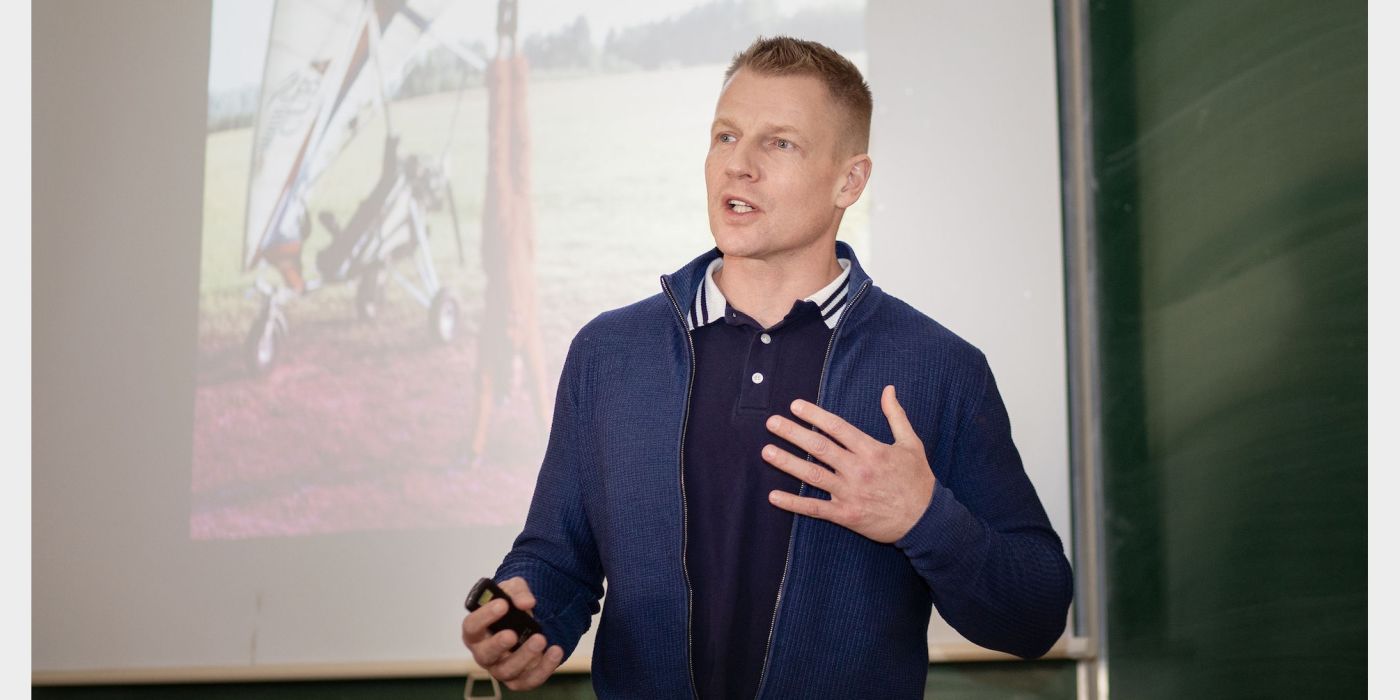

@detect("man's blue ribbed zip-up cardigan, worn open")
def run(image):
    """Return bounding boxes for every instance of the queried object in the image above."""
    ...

[496,242,1072,699]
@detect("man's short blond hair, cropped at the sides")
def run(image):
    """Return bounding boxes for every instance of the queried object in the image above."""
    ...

[724,36,875,154]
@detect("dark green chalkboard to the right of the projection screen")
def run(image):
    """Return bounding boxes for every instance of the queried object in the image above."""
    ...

[1089,0,1366,699]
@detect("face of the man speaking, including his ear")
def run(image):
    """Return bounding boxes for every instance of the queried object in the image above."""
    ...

[704,69,869,260]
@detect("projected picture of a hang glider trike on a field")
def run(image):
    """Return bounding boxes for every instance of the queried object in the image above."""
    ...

[190,0,867,539]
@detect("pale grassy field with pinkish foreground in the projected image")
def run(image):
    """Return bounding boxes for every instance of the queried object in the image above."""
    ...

[190,66,869,539]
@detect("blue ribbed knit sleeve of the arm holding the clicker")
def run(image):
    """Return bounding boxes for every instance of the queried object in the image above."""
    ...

[496,337,603,658]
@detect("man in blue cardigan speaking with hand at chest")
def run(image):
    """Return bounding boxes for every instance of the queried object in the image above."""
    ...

[462,38,1071,697]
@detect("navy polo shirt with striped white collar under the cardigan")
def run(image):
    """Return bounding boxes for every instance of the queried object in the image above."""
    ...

[685,259,850,699]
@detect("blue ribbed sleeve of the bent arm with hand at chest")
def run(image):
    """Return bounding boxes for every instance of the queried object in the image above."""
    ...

[896,364,1074,658]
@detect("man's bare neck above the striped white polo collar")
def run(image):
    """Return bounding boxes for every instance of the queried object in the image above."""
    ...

[714,245,841,328]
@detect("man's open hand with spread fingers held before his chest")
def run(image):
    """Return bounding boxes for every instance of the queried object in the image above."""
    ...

[763,386,935,543]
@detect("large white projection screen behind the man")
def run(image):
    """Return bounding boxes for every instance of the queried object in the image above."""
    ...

[32,0,1077,682]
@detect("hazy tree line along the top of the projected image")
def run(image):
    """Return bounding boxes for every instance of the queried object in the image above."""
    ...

[209,0,865,132]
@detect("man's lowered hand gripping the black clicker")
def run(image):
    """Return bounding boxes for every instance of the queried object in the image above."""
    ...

[462,577,564,690]
